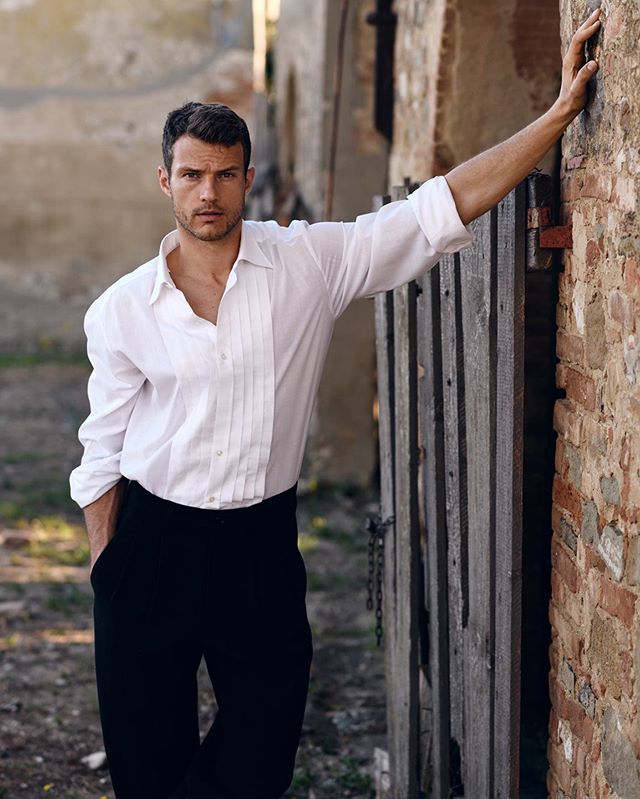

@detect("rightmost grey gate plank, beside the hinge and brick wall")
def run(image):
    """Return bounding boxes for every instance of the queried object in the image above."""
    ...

[494,181,526,799]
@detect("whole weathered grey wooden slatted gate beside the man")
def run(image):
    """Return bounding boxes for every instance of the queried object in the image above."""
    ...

[375,174,550,799]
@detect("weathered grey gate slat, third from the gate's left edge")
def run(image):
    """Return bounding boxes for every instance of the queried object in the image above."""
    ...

[417,265,450,799]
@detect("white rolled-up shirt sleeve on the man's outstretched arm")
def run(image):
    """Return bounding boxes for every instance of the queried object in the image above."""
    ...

[307,175,474,316]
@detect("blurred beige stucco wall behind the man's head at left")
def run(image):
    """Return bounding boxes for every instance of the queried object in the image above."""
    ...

[0,0,252,350]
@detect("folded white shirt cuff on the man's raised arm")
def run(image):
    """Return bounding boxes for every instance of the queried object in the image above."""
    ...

[407,175,475,252]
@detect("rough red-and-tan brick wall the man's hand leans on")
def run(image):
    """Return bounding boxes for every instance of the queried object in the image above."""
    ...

[547,0,640,799]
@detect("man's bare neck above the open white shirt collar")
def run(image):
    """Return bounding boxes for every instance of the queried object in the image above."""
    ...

[167,221,242,282]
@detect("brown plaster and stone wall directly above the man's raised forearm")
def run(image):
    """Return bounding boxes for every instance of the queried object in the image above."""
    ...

[391,0,560,183]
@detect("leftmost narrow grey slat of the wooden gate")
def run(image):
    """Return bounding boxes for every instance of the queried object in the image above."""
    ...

[373,196,401,799]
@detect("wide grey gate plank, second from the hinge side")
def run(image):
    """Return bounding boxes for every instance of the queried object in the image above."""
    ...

[460,209,496,797]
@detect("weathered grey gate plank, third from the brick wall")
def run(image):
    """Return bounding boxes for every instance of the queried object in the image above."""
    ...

[440,254,468,776]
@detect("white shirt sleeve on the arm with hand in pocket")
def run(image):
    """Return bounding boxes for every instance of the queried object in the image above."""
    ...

[69,304,145,508]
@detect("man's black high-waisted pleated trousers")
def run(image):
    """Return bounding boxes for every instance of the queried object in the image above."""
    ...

[91,482,313,799]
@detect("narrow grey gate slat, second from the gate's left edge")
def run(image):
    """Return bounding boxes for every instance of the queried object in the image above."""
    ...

[389,187,420,799]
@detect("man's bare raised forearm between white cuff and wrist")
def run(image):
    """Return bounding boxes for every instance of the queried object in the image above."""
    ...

[445,103,573,225]
